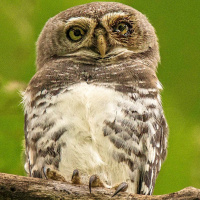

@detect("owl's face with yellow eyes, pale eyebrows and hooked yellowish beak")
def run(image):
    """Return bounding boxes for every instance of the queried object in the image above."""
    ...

[61,11,152,60]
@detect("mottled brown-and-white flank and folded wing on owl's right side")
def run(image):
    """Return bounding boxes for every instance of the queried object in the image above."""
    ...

[104,94,168,195]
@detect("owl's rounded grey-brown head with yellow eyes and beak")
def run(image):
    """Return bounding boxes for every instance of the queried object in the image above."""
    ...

[37,2,160,69]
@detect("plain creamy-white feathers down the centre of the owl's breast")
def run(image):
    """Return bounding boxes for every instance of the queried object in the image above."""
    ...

[49,83,128,185]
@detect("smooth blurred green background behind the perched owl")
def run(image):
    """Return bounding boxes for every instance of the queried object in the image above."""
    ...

[0,0,200,194]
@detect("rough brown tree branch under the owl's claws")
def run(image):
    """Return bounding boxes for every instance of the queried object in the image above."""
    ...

[0,173,200,200]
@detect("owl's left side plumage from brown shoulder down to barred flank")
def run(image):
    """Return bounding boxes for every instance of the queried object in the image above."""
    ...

[23,65,78,178]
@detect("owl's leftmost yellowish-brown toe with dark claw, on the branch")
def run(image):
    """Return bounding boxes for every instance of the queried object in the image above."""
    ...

[43,167,66,182]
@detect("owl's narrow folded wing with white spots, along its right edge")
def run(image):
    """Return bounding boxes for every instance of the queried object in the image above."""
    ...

[138,112,168,195]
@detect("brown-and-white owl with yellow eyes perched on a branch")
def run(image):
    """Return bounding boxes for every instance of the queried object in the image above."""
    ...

[23,2,168,195]
